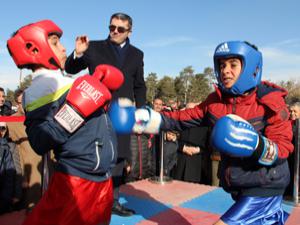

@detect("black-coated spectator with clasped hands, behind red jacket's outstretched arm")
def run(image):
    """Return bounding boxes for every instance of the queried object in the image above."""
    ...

[174,102,209,183]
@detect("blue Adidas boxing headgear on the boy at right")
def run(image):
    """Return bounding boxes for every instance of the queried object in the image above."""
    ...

[214,41,262,95]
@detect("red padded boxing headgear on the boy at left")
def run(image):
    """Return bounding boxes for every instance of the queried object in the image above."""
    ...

[7,20,63,69]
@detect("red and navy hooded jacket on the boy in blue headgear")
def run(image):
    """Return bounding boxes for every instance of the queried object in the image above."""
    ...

[161,82,294,196]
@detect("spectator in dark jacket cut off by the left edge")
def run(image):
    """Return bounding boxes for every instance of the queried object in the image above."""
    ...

[0,122,16,214]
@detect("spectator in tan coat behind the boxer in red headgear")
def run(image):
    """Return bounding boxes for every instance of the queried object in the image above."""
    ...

[7,89,41,210]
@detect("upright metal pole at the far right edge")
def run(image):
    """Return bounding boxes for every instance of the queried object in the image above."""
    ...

[293,119,300,206]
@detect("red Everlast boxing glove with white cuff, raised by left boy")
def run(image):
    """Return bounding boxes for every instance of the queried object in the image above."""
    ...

[55,65,124,133]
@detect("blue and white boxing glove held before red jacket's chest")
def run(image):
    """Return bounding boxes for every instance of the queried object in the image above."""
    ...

[210,114,278,165]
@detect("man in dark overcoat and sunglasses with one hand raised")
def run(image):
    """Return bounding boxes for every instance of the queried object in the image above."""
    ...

[65,13,146,216]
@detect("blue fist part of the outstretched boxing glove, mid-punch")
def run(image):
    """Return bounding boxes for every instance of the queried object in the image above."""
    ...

[108,98,135,134]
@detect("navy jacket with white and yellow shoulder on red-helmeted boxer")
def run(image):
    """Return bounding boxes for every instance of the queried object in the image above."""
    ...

[23,69,117,182]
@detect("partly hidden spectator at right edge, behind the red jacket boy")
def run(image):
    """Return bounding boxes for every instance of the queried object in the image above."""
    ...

[285,101,300,198]
